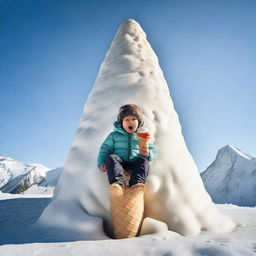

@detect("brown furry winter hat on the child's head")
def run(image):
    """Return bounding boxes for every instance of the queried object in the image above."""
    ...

[117,104,143,126]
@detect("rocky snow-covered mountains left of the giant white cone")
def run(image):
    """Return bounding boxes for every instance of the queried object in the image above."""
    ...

[0,156,62,194]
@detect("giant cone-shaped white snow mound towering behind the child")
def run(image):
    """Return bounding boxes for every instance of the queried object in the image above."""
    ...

[39,19,235,239]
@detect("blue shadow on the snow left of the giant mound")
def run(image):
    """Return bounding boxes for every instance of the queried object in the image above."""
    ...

[0,198,104,245]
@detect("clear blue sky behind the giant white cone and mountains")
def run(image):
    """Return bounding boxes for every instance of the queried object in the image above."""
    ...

[0,0,256,171]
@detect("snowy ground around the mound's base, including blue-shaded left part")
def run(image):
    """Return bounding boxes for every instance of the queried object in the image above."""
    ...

[0,194,256,256]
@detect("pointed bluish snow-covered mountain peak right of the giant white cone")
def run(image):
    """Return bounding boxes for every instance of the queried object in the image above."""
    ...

[201,145,256,206]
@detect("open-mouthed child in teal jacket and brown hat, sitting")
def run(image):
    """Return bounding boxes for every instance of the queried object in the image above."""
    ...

[98,104,157,186]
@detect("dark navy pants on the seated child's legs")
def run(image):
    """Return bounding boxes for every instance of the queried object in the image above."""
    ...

[105,154,149,186]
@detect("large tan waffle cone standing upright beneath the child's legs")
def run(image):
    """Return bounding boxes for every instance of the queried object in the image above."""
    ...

[109,183,146,239]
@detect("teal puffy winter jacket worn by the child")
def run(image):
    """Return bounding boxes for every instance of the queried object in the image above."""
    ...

[97,122,157,166]
